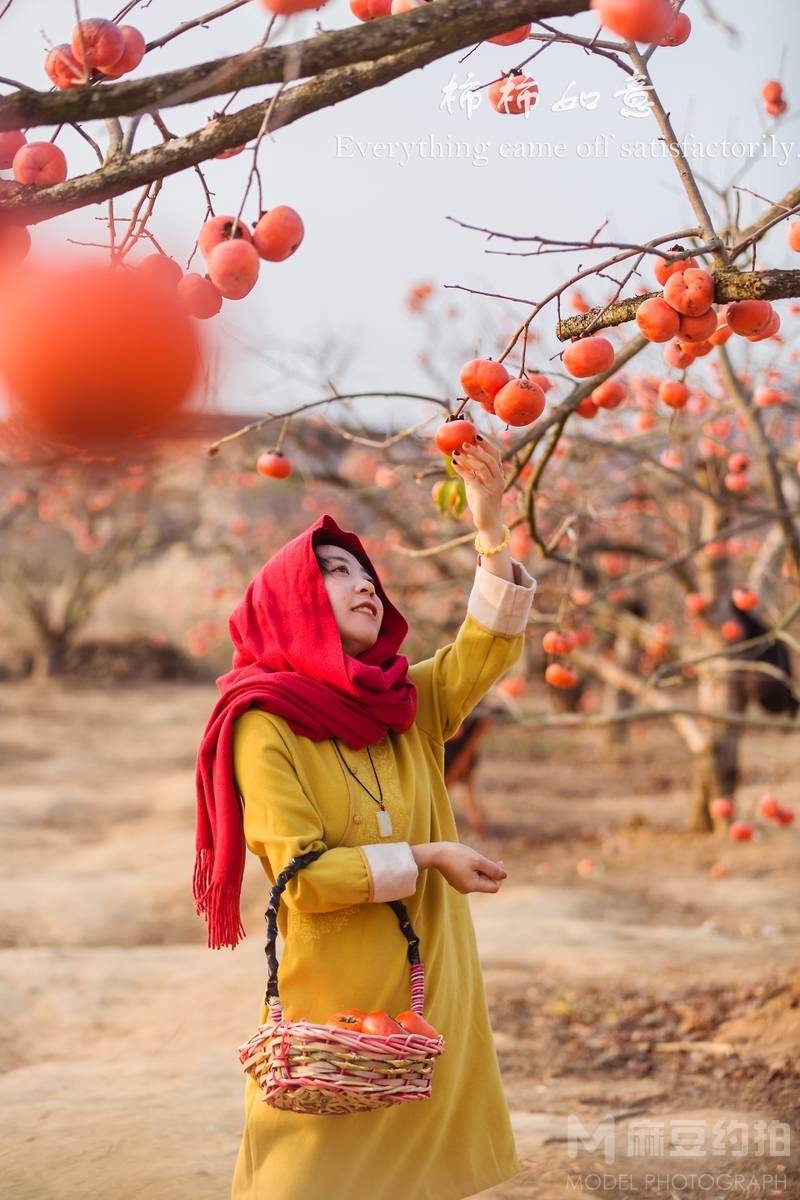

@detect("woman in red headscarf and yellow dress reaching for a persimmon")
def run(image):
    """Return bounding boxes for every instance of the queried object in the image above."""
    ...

[194,440,536,1200]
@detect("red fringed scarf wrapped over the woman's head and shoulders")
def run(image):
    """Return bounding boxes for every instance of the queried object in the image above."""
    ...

[193,514,416,949]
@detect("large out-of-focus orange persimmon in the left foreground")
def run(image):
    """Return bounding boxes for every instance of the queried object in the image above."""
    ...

[0,259,201,449]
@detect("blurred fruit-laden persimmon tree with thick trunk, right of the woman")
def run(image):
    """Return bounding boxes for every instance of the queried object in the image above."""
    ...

[388,249,800,829]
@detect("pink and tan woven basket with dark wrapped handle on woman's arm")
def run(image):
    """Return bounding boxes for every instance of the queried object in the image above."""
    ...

[237,850,445,1116]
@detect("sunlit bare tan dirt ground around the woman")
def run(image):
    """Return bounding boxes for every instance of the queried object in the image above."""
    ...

[0,684,800,1200]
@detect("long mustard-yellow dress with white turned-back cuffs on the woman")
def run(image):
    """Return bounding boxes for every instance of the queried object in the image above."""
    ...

[230,560,536,1200]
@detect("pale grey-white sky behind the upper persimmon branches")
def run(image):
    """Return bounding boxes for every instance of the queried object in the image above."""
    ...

[0,0,800,424]
